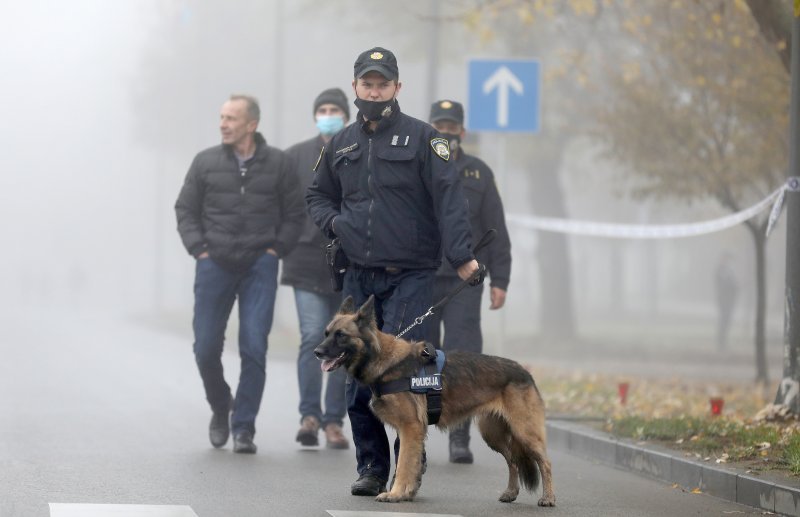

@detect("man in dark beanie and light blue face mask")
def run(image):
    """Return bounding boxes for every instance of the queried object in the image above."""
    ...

[281,88,350,449]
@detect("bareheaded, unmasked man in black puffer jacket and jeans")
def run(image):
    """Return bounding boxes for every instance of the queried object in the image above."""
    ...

[175,95,305,453]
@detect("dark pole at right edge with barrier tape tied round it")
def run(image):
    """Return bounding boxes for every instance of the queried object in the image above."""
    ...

[775,0,800,415]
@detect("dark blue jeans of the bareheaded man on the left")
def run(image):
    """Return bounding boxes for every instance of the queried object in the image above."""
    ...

[192,253,278,433]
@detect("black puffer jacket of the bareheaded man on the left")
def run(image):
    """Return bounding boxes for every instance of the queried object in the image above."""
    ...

[175,133,304,271]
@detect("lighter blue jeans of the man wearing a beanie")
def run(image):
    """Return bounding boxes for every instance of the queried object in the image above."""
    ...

[294,288,347,428]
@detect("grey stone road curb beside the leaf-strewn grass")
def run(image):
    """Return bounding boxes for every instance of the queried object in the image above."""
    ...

[547,419,800,517]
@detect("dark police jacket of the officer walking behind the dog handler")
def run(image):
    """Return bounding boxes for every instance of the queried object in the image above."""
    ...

[437,149,511,290]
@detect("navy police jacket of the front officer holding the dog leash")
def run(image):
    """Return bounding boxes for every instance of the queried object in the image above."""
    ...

[306,103,473,269]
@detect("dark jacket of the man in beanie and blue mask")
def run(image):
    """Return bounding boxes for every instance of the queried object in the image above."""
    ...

[281,135,333,294]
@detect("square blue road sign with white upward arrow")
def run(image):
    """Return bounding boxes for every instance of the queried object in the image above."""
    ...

[467,59,539,133]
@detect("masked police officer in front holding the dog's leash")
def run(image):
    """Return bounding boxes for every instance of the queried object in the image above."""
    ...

[306,47,478,496]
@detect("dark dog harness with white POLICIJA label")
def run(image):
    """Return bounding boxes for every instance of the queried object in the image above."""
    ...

[369,343,445,425]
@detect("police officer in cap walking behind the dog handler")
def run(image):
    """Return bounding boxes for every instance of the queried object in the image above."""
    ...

[428,100,511,463]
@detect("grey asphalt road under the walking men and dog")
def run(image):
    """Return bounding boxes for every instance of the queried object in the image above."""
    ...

[0,312,772,517]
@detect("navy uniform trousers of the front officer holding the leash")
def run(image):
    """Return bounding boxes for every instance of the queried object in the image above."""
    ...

[343,266,436,482]
